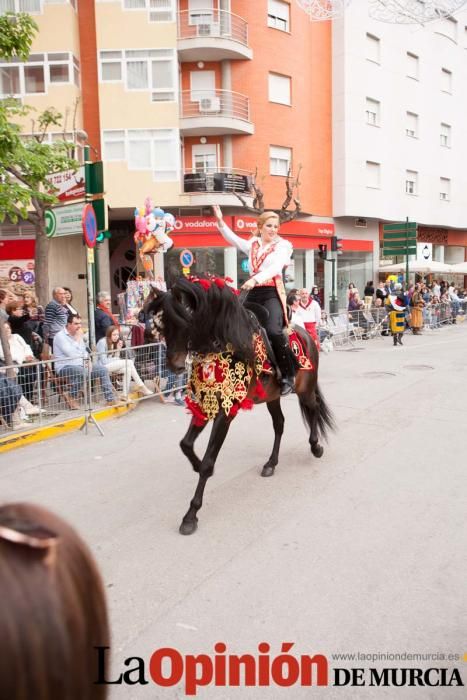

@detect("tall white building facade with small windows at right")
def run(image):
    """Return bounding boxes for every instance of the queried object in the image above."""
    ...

[333,0,467,304]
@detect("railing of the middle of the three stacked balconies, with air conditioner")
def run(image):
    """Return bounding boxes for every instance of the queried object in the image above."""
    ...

[180,90,250,122]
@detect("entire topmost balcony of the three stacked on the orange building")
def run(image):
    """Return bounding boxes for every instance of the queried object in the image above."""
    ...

[177,8,253,63]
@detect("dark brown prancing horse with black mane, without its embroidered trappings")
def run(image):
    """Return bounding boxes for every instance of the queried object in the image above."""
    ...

[146,278,334,535]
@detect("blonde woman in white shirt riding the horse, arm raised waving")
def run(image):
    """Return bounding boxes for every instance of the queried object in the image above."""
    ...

[213,205,296,396]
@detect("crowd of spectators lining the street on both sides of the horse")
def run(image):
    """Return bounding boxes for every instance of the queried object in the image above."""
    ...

[0,279,467,428]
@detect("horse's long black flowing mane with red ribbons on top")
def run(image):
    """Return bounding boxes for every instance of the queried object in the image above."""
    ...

[150,277,258,362]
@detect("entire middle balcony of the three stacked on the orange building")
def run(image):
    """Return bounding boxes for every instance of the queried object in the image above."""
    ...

[180,90,255,136]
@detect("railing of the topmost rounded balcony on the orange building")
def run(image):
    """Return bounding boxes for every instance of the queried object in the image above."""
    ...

[177,7,248,47]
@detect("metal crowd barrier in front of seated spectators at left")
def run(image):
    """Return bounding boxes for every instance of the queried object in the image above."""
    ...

[0,343,188,436]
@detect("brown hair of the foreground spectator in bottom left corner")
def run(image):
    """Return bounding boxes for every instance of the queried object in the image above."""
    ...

[0,503,109,700]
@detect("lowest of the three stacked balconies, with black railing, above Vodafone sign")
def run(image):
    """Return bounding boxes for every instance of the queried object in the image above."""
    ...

[183,168,253,205]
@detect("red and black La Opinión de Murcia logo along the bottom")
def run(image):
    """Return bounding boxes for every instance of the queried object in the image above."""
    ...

[95,642,464,696]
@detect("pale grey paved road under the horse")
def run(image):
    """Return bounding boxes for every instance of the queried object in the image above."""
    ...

[0,324,467,700]
